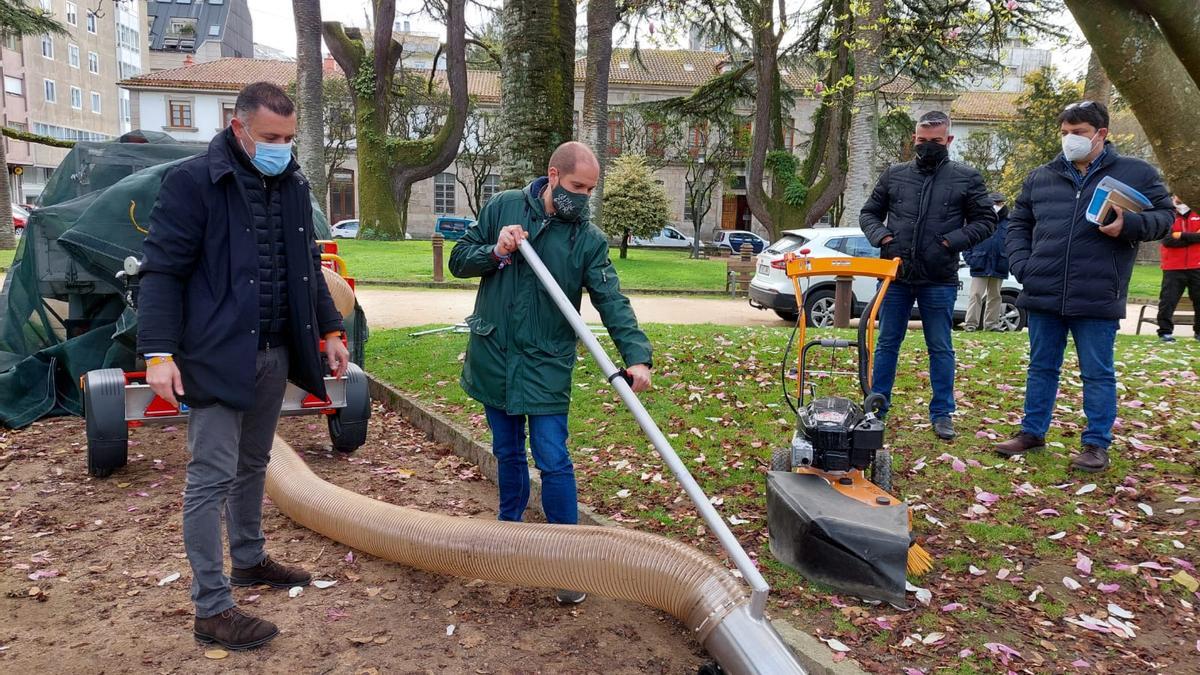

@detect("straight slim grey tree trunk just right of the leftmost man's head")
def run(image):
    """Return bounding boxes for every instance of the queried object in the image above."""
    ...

[292,0,329,210]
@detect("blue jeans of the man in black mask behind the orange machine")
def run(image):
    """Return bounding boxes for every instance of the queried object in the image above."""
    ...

[871,282,958,419]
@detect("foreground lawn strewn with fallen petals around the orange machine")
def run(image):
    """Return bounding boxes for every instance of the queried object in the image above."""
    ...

[367,324,1200,673]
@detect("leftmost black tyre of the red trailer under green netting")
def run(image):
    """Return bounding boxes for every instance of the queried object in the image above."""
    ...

[83,368,130,478]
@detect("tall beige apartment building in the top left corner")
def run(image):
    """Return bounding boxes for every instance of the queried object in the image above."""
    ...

[0,0,145,202]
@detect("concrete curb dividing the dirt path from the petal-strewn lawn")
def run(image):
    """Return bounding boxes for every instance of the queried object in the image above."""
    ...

[367,372,866,675]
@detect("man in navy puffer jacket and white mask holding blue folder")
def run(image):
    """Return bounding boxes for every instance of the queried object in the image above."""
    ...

[996,101,1174,472]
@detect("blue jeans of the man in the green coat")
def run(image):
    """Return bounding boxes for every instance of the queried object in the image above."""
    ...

[484,406,580,525]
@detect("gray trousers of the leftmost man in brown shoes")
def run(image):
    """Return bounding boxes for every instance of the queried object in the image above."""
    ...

[184,347,288,619]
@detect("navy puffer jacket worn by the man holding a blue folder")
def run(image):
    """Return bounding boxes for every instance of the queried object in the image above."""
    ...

[1006,144,1175,319]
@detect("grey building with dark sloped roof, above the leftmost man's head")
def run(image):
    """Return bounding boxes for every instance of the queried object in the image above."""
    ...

[145,0,253,72]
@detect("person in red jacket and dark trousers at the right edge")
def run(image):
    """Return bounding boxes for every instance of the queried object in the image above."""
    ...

[1158,195,1200,342]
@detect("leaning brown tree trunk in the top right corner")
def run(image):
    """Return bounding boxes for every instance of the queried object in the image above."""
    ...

[1066,0,1200,203]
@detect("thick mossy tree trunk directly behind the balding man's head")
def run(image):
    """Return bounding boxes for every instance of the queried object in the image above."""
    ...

[500,0,575,187]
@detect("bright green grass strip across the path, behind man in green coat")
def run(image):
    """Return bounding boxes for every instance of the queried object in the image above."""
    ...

[337,239,725,292]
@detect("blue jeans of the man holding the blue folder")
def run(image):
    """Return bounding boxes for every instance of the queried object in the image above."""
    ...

[1021,311,1120,448]
